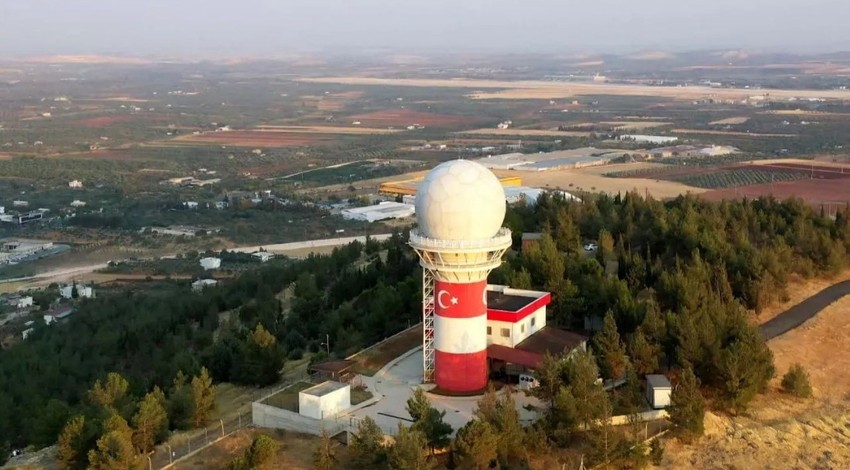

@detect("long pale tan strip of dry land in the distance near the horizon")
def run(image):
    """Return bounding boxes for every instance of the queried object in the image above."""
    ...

[302,77,850,100]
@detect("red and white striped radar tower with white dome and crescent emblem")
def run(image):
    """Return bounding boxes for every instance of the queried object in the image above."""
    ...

[410,160,511,393]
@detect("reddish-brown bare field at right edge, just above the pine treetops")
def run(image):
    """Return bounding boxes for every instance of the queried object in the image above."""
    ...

[700,178,850,206]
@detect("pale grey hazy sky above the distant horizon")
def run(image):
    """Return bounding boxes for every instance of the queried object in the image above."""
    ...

[0,0,850,58]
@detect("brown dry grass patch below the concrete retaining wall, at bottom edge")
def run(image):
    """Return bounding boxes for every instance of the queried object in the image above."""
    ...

[173,428,349,470]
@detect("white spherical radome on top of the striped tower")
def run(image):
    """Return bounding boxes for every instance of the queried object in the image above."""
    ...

[416,160,505,240]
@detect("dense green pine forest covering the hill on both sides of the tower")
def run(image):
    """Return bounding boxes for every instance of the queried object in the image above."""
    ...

[0,189,850,466]
